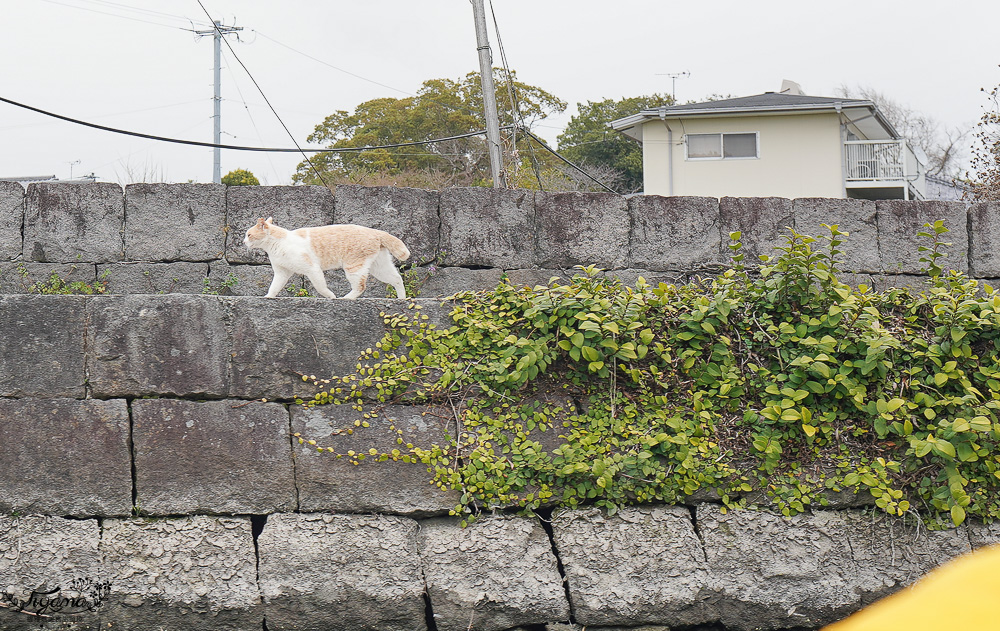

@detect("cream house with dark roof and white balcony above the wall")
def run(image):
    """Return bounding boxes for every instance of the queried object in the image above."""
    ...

[610,81,926,199]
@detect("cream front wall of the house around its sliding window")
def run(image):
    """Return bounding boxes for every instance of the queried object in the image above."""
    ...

[642,113,844,198]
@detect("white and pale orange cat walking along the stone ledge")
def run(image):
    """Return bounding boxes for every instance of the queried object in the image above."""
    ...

[243,217,410,300]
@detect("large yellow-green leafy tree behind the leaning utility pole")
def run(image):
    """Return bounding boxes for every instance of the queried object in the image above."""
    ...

[293,69,566,188]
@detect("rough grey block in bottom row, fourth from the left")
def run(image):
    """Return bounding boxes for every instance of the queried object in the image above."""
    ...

[418,516,569,631]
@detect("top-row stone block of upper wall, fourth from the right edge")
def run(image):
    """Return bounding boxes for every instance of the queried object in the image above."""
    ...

[719,197,795,265]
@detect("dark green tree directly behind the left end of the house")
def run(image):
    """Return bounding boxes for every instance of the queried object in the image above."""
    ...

[558,94,674,193]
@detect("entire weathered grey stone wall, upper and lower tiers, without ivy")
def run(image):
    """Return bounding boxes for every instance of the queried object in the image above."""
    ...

[0,184,1000,631]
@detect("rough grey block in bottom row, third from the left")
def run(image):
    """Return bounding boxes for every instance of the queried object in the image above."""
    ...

[257,514,424,631]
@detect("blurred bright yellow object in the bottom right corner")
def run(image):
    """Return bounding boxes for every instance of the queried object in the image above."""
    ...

[823,546,1000,631]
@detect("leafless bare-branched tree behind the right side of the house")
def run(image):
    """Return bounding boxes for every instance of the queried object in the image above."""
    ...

[838,85,969,178]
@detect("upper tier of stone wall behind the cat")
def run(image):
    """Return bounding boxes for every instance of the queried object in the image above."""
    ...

[0,182,1000,297]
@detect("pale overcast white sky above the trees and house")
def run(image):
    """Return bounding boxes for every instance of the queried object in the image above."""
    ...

[0,0,1000,184]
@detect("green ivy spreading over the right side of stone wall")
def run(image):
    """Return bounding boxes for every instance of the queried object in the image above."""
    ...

[297,222,1000,525]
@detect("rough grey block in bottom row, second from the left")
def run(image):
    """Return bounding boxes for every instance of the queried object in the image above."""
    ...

[100,515,264,631]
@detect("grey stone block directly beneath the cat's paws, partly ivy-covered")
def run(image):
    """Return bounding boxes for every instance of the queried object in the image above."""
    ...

[229,298,446,399]
